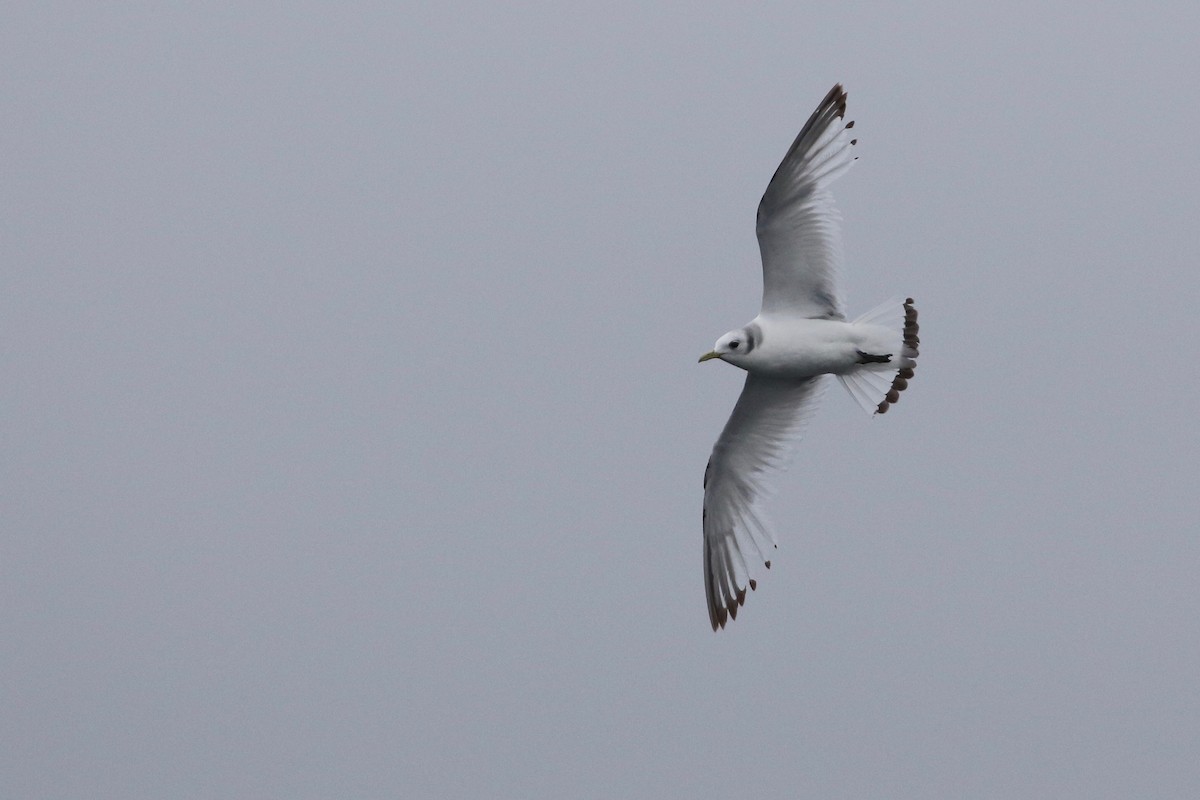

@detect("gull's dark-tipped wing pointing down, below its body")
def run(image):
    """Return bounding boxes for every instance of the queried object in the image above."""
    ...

[703,374,823,631]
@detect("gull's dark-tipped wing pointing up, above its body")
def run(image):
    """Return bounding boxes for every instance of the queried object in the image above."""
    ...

[757,84,858,319]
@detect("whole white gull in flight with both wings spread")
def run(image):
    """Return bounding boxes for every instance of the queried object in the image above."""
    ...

[700,84,919,631]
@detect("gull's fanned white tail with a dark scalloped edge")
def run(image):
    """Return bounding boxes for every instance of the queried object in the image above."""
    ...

[838,297,920,414]
